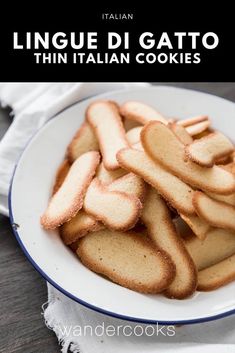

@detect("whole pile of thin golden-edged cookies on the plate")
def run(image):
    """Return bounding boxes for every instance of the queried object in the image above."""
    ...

[41,100,235,299]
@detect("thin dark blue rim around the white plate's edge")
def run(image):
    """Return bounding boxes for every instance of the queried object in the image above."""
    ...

[8,86,235,325]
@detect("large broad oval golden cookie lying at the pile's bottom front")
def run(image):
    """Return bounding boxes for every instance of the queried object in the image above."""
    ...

[77,229,175,294]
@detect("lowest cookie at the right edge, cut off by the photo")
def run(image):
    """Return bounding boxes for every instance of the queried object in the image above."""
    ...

[197,254,235,291]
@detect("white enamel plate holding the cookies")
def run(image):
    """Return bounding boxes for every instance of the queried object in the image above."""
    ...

[9,87,235,324]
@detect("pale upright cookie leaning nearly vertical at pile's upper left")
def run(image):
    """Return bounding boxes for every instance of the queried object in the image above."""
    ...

[86,101,129,170]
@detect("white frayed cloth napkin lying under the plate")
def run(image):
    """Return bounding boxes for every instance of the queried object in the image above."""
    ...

[0,83,235,353]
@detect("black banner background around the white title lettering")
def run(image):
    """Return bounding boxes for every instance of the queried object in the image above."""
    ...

[0,6,235,82]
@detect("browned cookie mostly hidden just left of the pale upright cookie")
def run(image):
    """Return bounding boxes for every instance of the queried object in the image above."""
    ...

[67,122,99,163]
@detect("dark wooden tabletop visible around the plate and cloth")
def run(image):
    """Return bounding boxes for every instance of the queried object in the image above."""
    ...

[0,83,235,353]
